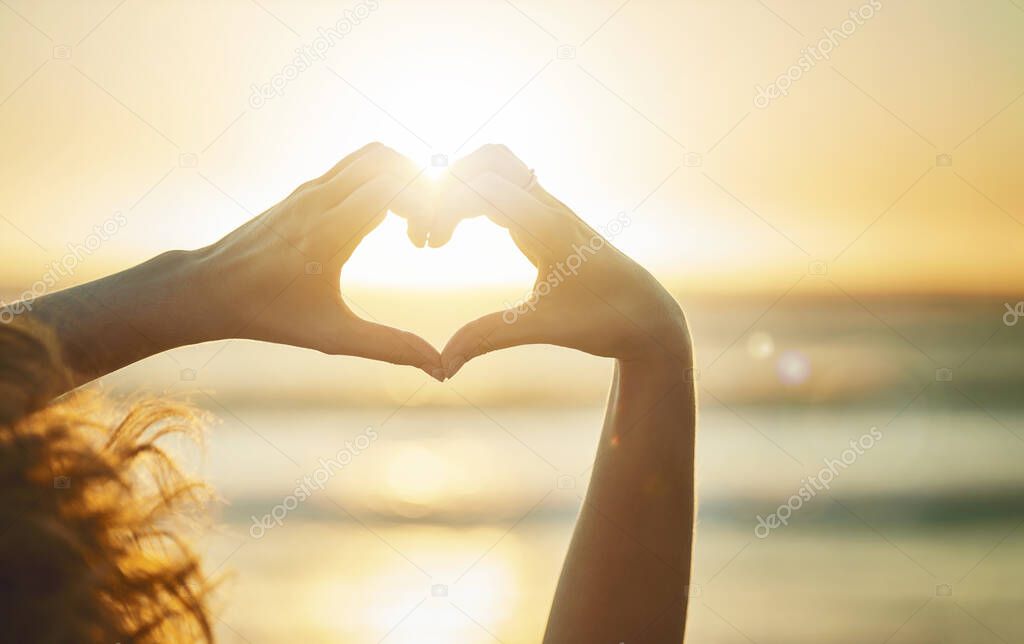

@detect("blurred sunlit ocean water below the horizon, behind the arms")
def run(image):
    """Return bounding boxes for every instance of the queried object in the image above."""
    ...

[75,294,1024,644]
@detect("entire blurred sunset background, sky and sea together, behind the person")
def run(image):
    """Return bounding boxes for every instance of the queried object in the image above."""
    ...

[0,0,1024,644]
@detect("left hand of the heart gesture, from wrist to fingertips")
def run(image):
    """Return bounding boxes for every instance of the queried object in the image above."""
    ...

[197,143,443,379]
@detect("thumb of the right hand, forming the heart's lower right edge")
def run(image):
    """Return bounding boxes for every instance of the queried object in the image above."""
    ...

[441,307,551,378]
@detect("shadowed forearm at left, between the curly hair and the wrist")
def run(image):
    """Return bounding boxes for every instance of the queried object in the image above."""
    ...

[18,251,217,386]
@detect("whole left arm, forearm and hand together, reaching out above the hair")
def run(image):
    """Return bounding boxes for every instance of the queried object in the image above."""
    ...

[10,143,443,385]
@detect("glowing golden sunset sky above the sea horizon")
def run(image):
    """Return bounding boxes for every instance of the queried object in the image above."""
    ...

[0,0,1024,293]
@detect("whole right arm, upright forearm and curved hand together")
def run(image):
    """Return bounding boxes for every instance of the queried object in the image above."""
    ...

[440,145,696,644]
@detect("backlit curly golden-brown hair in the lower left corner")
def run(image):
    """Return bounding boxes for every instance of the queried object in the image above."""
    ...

[0,324,213,642]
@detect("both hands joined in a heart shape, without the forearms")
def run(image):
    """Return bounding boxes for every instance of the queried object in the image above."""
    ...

[202,143,689,380]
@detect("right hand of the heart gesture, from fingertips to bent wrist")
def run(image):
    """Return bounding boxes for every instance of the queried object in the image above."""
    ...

[430,145,691,378]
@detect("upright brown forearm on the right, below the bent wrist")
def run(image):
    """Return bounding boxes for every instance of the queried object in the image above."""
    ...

[545,339,696,644]
